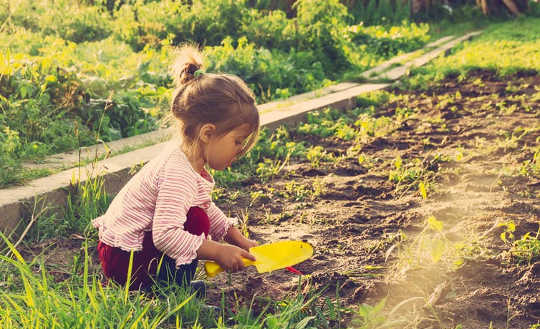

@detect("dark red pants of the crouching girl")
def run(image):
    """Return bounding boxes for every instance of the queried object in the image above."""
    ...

[97,207,210,290]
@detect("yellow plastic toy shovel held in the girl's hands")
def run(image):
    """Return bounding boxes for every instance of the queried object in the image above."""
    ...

[204,240,313,277]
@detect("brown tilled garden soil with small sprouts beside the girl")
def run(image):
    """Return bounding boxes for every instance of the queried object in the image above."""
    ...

[20,71,540,328]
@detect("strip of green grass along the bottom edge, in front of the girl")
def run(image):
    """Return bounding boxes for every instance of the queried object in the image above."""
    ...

[0,231,339,329]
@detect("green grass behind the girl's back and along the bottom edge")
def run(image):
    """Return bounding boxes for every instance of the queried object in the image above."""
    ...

[0,168,348,329]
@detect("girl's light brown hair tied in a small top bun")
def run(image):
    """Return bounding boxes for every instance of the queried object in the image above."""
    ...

[171,45,260,155]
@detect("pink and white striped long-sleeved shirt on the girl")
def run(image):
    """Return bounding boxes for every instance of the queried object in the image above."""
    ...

[92,142,235,266]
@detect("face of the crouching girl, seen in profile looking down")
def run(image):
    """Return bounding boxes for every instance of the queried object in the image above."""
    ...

[205,123,251,170]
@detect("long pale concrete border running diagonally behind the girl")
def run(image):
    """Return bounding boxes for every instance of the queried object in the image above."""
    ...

[0,32,480,233]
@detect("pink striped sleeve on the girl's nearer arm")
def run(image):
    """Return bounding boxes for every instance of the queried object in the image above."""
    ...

[152,166,204,266]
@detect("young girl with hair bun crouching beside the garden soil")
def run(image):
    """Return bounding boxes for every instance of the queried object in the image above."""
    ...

[93,46,259,289]
